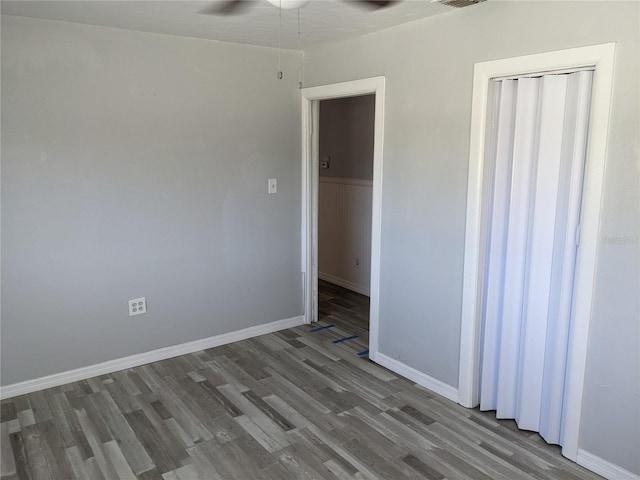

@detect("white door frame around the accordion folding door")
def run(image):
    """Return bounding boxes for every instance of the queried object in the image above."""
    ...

[458,43,615,461]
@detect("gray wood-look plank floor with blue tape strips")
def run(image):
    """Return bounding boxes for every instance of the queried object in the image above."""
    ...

[0,280,600,480]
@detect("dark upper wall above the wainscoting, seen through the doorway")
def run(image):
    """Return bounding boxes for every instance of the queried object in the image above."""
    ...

[319,95,376,180]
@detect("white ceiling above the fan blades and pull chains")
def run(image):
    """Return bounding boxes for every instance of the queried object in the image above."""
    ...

[2,0,460,50]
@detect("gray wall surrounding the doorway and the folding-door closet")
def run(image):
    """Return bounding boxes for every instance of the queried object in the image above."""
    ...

[305,1,640,474]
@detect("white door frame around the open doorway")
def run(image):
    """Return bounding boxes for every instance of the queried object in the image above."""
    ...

[302,77,385,361]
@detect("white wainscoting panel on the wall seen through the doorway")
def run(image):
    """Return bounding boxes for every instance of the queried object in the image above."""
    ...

[318,177,373,295]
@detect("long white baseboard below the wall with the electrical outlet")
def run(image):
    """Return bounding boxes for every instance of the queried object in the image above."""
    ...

[0,316,304,399]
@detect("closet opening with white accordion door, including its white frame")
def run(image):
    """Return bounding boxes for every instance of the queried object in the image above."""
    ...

[458,44,615,463]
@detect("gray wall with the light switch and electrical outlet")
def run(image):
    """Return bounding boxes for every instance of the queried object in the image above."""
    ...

[1,17,302,385]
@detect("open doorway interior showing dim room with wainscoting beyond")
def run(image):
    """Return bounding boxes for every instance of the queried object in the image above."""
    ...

[318,94,375,344]
